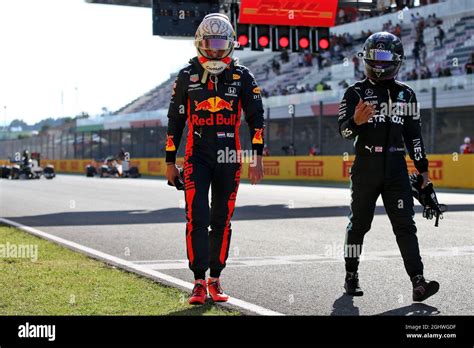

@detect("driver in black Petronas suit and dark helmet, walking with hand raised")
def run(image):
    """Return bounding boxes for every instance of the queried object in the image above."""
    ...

[338,32,439,301]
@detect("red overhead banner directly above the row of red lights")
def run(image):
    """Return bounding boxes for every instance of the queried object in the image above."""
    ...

[239,0,338,27]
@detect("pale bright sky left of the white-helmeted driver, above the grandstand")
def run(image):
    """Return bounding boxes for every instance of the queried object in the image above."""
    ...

[0,0,195,126]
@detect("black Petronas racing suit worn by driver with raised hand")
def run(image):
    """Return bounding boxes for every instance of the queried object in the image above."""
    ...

[338,79,428,277]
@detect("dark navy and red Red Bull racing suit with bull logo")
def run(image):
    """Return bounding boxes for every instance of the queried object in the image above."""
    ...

[166,58,264,279]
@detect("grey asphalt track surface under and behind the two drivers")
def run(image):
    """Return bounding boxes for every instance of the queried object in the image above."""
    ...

[0,175,474,315]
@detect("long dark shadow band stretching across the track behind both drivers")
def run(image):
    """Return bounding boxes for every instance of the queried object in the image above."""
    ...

[8,204,474,226]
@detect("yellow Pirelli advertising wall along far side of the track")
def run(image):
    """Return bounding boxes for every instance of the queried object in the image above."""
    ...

[0,153,474,189]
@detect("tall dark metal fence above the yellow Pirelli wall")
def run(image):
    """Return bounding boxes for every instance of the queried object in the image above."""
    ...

[0,107,474,159]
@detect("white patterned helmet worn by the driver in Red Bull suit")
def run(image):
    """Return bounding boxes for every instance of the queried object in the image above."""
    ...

[194,13,236,74]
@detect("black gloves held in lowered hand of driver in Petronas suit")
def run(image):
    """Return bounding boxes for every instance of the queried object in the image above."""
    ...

[410,174,448,227]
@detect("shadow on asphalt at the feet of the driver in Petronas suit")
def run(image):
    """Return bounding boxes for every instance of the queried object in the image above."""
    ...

[331,294,440,316]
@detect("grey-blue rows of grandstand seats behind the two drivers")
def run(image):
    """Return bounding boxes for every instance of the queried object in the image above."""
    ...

[115,5,474,114]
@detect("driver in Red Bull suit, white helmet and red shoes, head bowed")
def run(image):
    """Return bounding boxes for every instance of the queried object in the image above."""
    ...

[166,13,264,304]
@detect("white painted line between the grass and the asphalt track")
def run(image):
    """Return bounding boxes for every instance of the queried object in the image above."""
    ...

[0,218,284,316]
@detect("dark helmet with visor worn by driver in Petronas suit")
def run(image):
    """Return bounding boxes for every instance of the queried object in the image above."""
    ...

[359,32,405,81]
